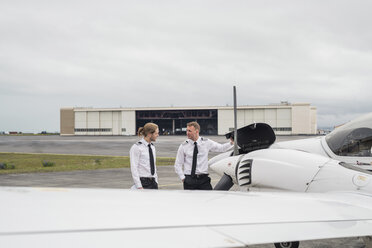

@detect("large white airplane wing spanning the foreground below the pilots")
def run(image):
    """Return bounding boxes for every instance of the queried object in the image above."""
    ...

[0,187,372,248]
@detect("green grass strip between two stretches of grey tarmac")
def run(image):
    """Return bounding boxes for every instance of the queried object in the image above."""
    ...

[0,152,175,174]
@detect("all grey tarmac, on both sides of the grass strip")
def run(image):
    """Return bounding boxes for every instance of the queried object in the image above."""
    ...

[0,136,365,248]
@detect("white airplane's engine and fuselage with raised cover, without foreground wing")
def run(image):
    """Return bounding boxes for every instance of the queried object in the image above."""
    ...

[209,113,372,193]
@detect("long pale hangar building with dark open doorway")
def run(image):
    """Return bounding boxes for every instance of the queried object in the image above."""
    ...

[60,102,317,135]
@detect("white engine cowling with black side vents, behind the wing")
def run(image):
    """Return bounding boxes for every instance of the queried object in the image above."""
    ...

[211,149,371,192]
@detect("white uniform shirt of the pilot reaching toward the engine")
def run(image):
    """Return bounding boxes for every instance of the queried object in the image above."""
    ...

[174,137,232,180]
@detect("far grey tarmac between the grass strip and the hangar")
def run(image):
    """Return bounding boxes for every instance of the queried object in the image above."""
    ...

[0,135,313,157]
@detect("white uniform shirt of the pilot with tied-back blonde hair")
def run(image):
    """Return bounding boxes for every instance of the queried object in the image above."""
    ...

[129,138,158,188]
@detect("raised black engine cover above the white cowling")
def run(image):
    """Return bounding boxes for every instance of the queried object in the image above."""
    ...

[225,123,276,154]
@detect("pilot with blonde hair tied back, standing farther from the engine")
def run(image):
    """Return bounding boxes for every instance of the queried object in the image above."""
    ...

[129,122,159,189]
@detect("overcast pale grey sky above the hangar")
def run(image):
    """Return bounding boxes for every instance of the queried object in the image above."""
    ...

[0,0,372,132]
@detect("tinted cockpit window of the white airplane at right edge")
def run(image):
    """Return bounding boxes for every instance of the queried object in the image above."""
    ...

[326,127,372,157]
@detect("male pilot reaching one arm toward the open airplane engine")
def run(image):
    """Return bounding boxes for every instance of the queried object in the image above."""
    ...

[174,122,233,190]
